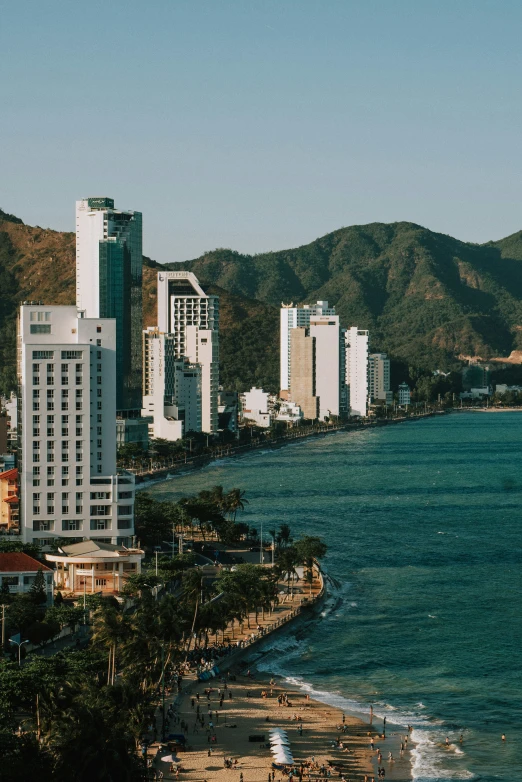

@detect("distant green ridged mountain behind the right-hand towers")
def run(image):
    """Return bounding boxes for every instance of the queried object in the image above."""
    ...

[170,223,522,369]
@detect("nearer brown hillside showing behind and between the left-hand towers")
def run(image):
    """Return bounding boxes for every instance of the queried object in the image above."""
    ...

[0,210,279,394]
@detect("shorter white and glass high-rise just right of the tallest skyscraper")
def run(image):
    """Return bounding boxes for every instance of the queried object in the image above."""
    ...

[142,328,201,440]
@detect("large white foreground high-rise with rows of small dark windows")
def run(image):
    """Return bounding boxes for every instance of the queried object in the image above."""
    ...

[17,304,134,545]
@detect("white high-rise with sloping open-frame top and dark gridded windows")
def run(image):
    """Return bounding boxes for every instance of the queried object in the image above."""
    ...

[158,271,219,433]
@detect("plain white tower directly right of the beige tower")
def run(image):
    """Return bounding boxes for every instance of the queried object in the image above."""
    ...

[310,315,346,419]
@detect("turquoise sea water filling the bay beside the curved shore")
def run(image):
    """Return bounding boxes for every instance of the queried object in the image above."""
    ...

[146,413,522,782]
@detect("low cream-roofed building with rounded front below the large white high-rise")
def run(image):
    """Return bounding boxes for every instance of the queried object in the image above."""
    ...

[45,540,145,594]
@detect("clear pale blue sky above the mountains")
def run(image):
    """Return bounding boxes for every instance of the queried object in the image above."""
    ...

[0,0,522,262]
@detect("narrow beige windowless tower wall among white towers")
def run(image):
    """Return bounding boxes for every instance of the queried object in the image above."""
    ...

[289,326,319,420]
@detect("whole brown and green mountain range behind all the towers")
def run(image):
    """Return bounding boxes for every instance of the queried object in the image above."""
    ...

[0,210,522,392]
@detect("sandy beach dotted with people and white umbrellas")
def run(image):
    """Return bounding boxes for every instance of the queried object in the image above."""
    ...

[150,665,411,782]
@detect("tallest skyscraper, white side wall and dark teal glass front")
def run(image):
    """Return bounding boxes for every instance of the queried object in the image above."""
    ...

[76,198,143,418]
